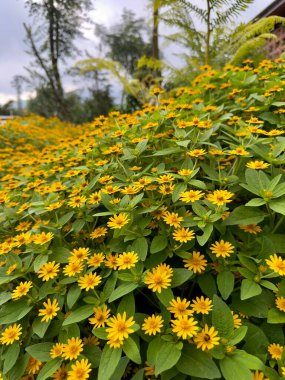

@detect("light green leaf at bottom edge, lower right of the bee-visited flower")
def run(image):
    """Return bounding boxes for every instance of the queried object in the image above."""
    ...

[220,356,252,380]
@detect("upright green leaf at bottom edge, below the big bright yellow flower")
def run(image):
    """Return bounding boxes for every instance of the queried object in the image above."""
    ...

[98,344,122,380]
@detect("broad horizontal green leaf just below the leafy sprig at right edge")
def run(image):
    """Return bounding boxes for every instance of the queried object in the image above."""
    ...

[223,206,266,226]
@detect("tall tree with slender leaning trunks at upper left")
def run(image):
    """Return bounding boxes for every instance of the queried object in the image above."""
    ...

[24,0,92,118]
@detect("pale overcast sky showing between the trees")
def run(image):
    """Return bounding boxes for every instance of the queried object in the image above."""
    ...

[0,0,272,104]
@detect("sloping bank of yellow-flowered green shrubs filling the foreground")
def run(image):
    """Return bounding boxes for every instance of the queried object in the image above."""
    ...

[0,61,285,380]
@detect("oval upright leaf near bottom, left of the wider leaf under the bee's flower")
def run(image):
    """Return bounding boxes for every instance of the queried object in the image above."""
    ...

[154,340,181,376]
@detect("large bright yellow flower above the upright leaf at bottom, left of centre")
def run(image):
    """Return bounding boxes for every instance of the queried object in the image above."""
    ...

[106,311,135,344]
